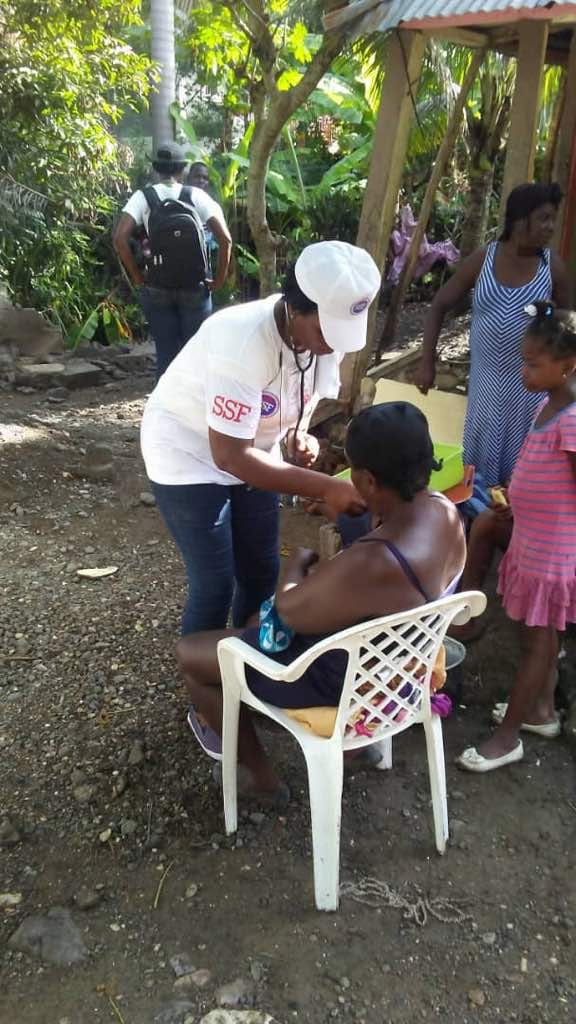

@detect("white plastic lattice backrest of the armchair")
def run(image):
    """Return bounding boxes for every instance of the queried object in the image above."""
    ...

[307,593,486,748]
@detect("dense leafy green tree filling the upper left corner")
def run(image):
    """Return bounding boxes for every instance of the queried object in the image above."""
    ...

[0,0,151,331]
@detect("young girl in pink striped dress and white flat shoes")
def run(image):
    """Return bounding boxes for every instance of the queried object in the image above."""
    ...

[458,302,576,772]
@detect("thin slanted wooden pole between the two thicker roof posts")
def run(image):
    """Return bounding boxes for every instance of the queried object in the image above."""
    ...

[384,48,486,354]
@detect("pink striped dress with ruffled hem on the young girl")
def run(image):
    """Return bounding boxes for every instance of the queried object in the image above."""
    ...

[498,398,576,630]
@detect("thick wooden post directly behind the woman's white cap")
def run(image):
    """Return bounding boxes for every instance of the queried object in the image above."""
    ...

[340,31,426,402]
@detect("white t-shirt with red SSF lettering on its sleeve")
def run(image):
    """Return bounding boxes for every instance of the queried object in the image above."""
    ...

[140,295,339,484]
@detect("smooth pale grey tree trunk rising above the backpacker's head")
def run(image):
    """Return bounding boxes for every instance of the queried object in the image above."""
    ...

[150,0,176,150]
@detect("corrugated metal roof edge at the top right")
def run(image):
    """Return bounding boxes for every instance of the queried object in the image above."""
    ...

[325,0,576,35]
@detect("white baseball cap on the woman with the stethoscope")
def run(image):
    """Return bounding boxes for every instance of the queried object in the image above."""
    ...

[294,242,381,352]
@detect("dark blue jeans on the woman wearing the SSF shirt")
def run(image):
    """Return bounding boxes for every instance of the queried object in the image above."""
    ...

[152,482,280,636]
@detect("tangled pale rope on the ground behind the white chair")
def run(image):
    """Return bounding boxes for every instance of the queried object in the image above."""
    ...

[340,878,471,928]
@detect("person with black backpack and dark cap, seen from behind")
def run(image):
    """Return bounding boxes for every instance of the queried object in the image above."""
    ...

[114,142,232,377]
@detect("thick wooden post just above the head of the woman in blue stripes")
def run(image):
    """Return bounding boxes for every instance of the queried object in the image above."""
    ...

[500,22,549,223]
